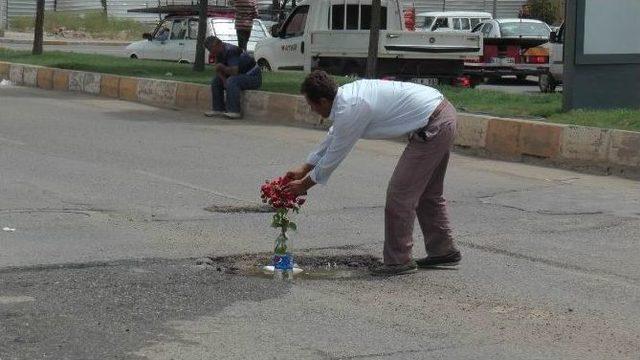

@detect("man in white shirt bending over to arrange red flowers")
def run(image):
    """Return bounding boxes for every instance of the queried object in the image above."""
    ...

[285,71,461,275]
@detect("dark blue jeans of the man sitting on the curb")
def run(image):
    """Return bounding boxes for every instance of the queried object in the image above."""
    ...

[211,68,262,113]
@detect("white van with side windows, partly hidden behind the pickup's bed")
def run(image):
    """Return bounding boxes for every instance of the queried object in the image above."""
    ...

[416,11,493,32]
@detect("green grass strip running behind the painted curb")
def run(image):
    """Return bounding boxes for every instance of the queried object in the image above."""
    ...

[0,48,640,131]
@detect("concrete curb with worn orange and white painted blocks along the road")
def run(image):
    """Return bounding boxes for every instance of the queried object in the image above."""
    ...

[0,62,640,178]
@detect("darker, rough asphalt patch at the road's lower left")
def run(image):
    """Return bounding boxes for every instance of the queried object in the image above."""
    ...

[0,260,288,360]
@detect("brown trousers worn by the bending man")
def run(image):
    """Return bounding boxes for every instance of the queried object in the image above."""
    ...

[383,99,457,265]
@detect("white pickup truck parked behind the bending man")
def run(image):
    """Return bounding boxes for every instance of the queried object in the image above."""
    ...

[255,0,482,85]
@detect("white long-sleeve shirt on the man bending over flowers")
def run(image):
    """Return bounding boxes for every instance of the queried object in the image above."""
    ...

[307,80,444,184]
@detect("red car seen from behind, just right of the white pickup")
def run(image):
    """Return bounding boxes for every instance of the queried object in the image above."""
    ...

[465,19,551,84]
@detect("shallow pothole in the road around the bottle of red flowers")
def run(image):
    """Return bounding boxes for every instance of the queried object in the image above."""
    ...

[197,252,380,280]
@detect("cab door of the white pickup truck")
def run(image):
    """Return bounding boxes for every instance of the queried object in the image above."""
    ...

[276,5,309,70]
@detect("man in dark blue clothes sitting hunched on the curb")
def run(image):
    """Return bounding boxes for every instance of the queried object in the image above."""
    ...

[204,36,262,119]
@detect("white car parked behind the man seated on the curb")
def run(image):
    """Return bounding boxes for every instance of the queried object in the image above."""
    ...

[125,15,270,63]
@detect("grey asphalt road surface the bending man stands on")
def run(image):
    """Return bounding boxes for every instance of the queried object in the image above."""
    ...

[0,87,640,360]
